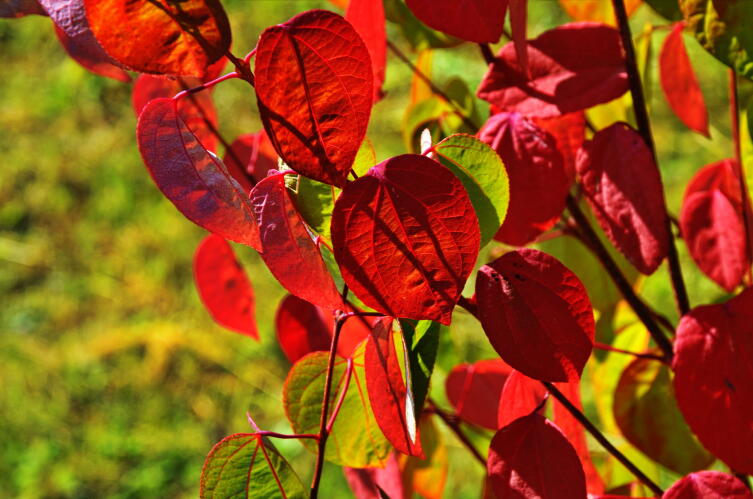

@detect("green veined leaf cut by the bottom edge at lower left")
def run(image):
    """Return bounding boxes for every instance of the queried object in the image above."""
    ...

[199,433,308,499]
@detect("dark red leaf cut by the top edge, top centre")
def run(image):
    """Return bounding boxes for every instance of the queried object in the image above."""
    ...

[406,0,507,43]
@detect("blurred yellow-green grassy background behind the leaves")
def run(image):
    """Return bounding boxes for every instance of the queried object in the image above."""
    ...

[0,0,747,498]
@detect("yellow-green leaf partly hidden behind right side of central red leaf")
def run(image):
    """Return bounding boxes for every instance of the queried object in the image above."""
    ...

[431,134,510,247]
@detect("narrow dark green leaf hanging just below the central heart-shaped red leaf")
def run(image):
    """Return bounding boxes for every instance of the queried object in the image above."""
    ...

[400,319,442,417]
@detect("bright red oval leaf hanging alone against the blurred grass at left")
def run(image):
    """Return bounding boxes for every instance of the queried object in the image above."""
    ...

[193,234,259,340]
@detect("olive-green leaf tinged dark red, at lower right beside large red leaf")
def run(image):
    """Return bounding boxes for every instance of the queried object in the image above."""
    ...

[614,358,714,474]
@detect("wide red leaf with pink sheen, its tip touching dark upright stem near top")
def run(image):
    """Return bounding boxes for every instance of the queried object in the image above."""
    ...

[478,23,628,117]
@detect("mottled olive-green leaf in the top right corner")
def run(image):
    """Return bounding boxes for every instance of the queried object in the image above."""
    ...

[680,0,753,79]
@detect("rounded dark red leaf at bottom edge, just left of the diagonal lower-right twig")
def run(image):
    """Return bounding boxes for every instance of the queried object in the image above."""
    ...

[487,414,586,499]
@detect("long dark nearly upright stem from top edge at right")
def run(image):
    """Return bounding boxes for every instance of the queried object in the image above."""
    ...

[612,0,690,315]
